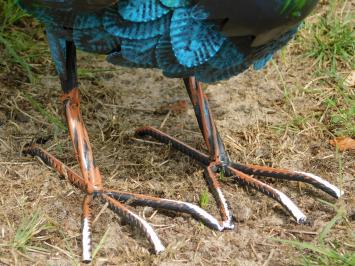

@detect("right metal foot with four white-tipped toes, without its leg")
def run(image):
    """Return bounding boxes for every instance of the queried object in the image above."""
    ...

[136,127,343,224]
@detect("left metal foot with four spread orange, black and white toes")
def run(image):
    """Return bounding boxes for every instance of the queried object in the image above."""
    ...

[23,145,225,263]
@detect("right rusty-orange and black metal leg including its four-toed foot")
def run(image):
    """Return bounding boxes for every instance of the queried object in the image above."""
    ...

[136,77,343,224]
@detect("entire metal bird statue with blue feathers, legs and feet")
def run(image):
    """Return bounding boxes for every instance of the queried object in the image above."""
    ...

[18,0,342,262]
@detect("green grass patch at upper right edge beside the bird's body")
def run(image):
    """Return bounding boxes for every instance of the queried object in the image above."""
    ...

[298,0,355,136]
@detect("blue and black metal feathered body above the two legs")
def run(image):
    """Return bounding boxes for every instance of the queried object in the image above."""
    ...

[20,0,317,82]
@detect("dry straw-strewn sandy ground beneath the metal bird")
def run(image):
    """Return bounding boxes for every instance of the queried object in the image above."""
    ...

[0,1,355,265]
